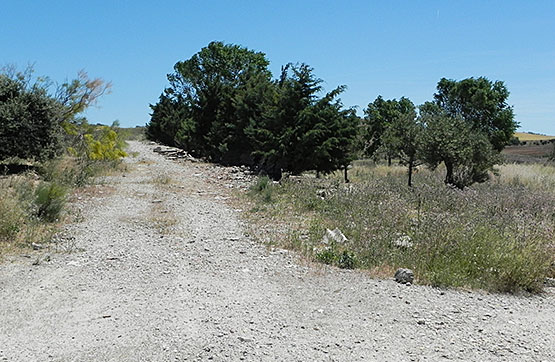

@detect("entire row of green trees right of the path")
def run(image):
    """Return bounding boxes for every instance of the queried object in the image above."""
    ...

[146,42,517,188]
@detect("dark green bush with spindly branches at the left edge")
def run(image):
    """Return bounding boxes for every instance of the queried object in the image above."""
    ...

[0,67,110,160]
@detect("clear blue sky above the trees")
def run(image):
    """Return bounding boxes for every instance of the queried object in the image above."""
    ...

[0,0,555,135]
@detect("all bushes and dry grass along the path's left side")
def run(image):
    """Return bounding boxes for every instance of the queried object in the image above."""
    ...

[0,68,126,258]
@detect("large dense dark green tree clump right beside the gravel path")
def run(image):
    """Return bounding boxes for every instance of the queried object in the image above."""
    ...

[146,42,358,179]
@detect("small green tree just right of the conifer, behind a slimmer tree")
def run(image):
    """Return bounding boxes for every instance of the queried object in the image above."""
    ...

[363,96,416,165]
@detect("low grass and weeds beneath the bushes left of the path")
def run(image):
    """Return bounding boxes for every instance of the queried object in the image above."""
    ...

[0,156,125,259]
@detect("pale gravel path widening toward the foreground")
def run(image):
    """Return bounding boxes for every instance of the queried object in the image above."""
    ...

[0,142,555,361]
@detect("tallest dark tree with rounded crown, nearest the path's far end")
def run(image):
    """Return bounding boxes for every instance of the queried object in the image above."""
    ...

[156,42,271,164]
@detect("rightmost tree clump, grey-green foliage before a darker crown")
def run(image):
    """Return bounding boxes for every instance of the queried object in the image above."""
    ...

[420,77,518,189]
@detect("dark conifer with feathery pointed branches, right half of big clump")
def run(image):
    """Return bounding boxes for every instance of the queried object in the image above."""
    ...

[248,64,359,180]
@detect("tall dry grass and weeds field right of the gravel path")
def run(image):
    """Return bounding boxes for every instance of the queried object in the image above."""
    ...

[252,165,555,292]
